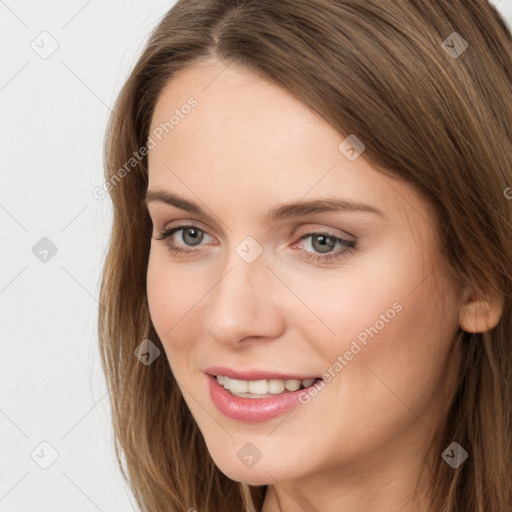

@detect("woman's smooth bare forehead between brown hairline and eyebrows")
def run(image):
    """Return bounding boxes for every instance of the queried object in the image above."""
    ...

[148,61,428,231]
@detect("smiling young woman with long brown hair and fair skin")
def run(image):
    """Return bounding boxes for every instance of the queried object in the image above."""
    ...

[99,0,512,512]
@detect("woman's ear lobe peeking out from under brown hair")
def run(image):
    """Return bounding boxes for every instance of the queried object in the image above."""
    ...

[459,288,504,333]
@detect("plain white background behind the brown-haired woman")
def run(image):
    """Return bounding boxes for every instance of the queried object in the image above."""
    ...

[0,0,512,512]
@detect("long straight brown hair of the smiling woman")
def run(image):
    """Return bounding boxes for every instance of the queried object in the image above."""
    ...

[98,0,512,512]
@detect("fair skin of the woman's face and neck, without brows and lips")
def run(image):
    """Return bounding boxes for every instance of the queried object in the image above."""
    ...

[147,57,499,512]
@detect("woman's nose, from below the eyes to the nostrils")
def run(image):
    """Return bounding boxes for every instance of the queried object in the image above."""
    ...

[205,251,289,347]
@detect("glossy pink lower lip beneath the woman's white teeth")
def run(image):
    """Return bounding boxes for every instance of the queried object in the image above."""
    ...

[207,375,315,423]
